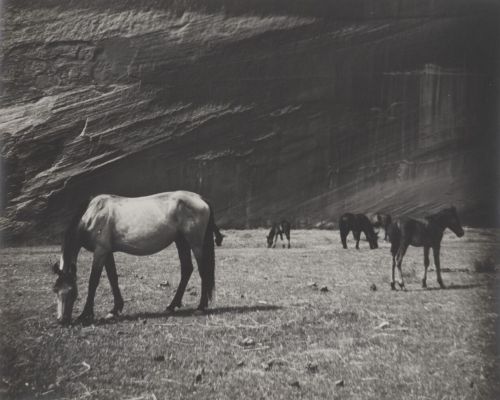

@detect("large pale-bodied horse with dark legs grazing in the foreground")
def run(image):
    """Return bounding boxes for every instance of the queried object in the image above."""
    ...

[54,191,215,324]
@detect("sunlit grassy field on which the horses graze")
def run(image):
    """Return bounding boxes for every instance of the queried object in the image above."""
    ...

[0,229,499,400]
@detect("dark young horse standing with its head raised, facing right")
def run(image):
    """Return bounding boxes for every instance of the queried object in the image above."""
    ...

[389,207,464,290]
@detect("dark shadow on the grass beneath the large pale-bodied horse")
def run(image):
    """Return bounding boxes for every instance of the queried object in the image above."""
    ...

[93,304,283,325]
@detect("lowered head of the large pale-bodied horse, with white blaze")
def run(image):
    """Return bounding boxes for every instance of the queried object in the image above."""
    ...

[53,262,78,325]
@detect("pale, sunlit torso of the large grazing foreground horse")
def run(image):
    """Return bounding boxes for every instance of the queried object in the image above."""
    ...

[78,191,210,255]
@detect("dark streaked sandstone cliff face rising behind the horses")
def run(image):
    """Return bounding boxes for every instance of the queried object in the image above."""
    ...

[0,0,498,240]
